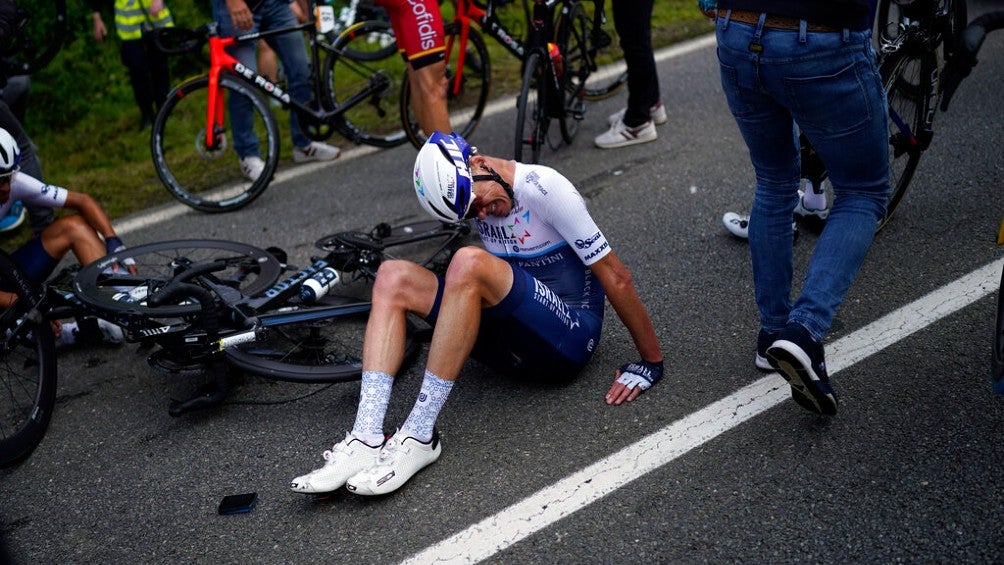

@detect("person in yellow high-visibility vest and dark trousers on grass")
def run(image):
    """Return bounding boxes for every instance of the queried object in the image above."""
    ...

[89,0,174,130]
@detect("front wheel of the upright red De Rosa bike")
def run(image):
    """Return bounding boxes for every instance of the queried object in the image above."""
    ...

[151,75,279,212]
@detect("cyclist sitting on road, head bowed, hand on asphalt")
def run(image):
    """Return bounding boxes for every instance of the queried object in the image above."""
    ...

[290,133,663,495]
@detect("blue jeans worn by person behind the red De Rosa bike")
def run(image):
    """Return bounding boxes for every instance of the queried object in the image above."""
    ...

[213,0,312,159]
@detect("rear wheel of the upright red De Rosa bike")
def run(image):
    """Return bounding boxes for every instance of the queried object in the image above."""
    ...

[323,21,408,148]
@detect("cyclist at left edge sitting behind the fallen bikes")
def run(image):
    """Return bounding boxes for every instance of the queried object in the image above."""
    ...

[0,128,136,343]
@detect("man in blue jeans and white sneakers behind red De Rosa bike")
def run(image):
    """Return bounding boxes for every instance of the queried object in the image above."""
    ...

[213,0,340,181]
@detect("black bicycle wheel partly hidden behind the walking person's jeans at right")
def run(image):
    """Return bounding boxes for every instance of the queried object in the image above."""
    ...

[879,48,923,230]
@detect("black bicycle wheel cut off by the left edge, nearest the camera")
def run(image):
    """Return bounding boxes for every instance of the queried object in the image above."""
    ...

[0,253,56,468]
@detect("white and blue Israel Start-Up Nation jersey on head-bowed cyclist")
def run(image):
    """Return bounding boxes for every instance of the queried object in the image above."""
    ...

[476,163,610,317]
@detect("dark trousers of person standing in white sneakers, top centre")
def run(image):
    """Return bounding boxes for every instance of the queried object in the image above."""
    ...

[611,0,659,127]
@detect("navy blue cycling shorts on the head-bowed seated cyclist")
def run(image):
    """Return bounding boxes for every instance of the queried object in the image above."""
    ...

[426,265,603,383]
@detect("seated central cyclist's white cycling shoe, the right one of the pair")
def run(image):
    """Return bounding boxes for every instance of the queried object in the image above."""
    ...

[345,430,443,496]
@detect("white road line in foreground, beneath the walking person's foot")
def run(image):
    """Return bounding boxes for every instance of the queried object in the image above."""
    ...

[405,259,1004,564]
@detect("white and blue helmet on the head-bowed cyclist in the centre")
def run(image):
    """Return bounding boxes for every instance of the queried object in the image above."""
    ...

[415,131,474,223]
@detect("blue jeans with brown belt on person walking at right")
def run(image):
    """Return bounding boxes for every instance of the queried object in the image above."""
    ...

[716,13,890,340]
